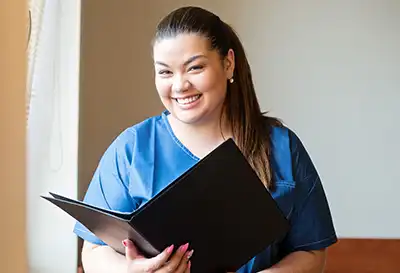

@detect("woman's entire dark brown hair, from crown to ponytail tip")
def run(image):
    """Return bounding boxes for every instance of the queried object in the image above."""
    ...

[154,6,282,189]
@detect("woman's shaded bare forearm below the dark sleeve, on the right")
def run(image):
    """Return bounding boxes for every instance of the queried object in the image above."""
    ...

[259,251,325,273]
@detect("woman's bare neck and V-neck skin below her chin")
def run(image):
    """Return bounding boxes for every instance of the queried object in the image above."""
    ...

[168,111,232,158]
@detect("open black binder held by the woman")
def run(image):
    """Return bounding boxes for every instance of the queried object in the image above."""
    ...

[42,139,290,273]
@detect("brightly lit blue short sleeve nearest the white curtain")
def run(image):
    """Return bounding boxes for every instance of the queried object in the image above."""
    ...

[74,129,135,245]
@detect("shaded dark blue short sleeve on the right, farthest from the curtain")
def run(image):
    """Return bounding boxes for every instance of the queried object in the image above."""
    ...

[284,131,337,253]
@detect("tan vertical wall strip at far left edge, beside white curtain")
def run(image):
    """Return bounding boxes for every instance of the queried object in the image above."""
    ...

[0,0,27,273]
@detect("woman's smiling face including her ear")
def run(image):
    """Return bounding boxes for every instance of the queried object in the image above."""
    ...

[153,34,234,124]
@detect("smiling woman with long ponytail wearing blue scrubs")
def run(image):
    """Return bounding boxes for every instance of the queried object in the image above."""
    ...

[75,4,337,273]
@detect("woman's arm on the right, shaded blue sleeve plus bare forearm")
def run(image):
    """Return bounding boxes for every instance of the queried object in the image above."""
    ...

[260,131,337,273]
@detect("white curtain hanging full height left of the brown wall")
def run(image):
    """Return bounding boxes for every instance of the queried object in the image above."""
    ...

[26,0,80,273]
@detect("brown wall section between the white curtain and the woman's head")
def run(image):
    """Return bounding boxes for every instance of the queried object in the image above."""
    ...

[79,0,160,199]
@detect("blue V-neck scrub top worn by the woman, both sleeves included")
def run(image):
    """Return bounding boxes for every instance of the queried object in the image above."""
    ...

[74,111,337,273]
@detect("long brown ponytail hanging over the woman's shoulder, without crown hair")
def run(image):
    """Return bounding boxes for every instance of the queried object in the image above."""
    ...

[223,23,282,189]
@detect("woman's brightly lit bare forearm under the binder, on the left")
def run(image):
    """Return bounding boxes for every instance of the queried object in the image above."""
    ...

[82,242,127,273]
